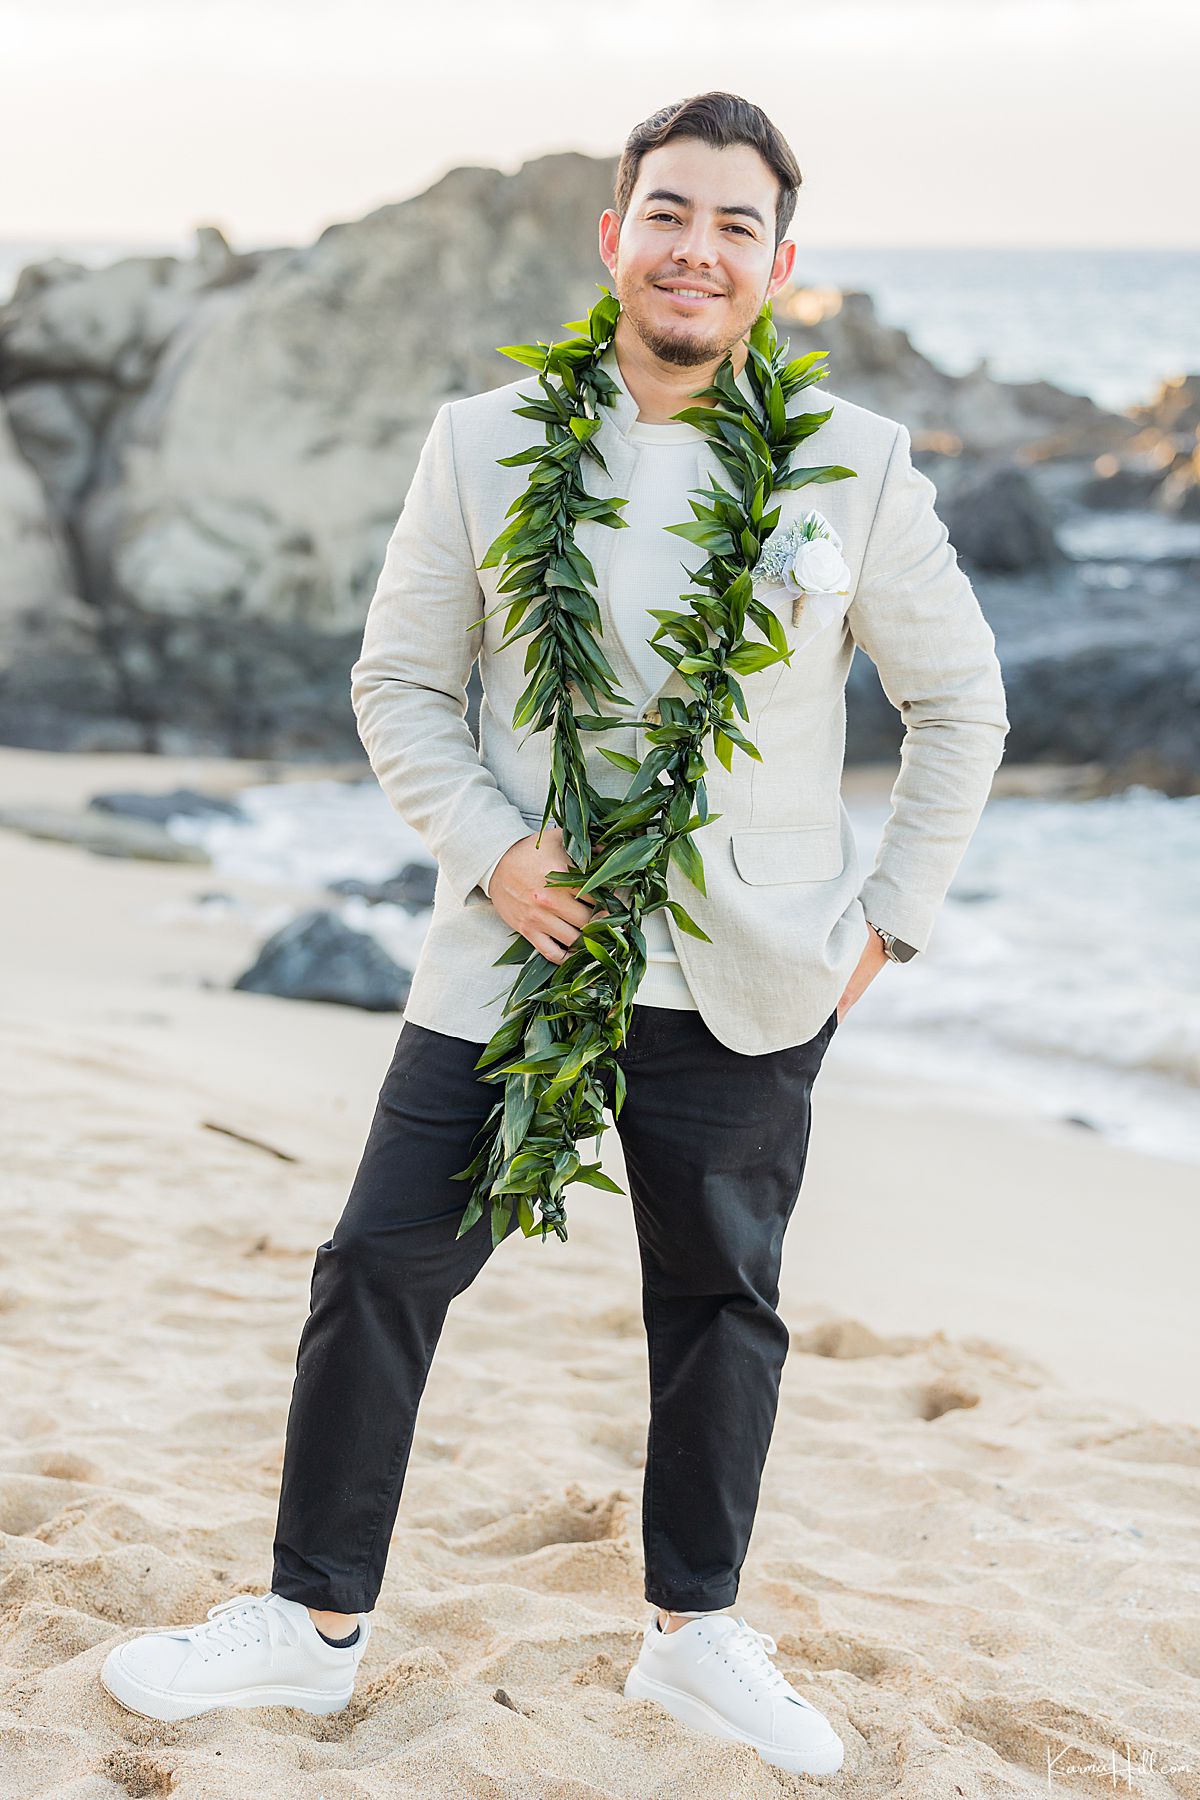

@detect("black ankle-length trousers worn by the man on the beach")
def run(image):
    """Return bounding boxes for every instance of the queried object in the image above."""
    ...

[272,1004,837,1613]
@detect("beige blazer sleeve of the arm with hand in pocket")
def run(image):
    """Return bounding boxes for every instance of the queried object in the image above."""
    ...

[847,425,1009,950]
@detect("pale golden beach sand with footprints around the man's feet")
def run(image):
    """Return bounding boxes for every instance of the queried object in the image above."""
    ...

[0,751,1200,1800]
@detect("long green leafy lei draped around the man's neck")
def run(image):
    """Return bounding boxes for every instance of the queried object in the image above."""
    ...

[452,298,855,1246]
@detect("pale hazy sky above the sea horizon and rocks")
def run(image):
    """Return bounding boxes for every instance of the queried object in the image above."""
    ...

[0,0,1200,250]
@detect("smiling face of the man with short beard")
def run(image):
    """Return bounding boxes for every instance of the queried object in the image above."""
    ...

[601,137,795,367]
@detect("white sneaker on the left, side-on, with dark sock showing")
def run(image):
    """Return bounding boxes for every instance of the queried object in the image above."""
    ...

[101,1593,371,1721]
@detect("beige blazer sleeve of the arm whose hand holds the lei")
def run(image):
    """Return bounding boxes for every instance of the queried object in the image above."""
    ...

[351,401,529,900]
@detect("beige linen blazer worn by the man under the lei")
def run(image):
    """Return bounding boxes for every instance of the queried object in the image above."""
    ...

[351,346,1009,1055]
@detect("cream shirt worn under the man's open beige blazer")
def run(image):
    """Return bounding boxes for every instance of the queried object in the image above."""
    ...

[484,419,705,1012]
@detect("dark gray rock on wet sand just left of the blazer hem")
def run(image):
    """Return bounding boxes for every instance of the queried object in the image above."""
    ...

[234,907,412,1012]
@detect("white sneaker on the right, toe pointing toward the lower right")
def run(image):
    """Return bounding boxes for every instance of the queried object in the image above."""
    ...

[624,1611,846,1775]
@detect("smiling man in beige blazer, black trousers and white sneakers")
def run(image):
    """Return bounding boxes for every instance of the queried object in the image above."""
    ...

[104,94,1007,1773]
